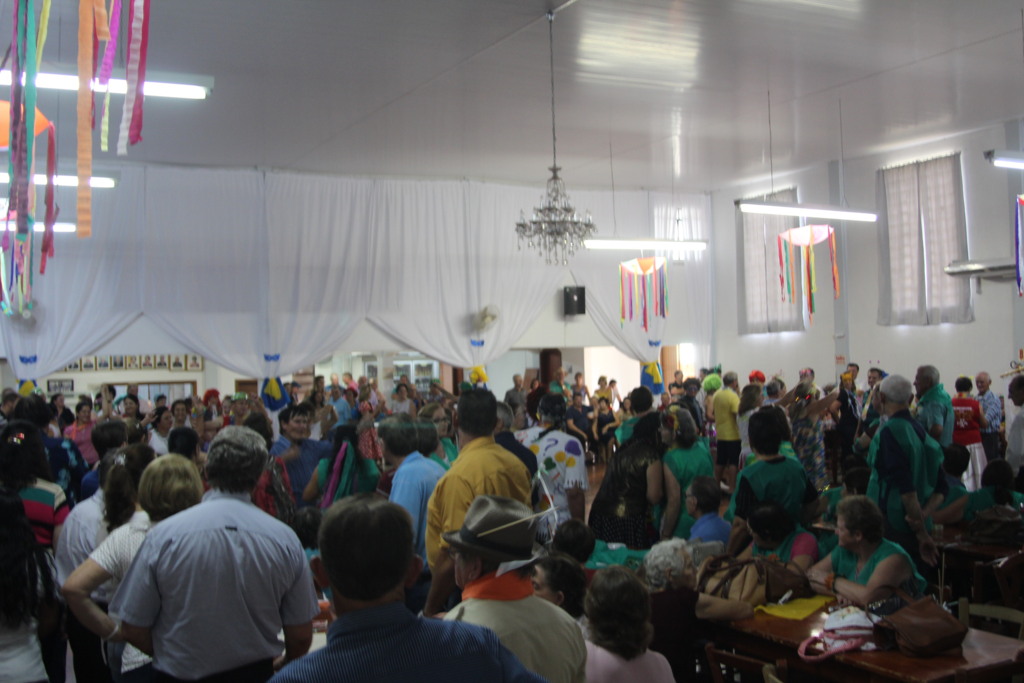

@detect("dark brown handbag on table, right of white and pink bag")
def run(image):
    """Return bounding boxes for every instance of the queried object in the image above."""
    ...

[874,589,968,657]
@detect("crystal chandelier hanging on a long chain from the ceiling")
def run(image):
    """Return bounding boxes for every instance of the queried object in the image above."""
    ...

[515,11,597,265]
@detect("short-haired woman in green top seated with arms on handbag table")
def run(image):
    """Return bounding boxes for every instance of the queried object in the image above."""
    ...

[807,496,925,605]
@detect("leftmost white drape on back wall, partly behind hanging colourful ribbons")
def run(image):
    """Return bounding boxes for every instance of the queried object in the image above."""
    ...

[0,169,142,380]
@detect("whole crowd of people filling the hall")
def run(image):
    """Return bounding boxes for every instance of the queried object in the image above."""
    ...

[0,364,1024,683]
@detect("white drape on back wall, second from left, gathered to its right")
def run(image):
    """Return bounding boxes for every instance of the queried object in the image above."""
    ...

[140,167,270,378]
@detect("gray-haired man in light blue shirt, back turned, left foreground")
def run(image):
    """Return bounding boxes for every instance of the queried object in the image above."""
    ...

[108,426,319,682]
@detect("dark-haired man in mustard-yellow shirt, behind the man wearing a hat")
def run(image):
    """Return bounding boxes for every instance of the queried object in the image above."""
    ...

[423,389,530,616]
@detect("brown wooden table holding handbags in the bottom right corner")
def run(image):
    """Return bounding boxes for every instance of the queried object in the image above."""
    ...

[715,610,1024,683]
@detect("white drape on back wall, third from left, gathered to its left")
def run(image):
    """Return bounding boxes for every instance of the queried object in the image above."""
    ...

[262,173,376,377]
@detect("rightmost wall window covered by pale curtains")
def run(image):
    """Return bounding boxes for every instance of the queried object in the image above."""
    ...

[878,153,974,325]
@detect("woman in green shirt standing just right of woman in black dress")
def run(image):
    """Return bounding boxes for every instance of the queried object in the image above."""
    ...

[662,405,715,541]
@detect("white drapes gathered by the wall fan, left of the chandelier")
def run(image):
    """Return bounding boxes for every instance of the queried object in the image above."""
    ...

[369,180,564,368]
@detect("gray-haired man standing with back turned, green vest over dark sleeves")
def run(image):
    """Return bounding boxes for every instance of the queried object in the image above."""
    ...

[867,375,949,568]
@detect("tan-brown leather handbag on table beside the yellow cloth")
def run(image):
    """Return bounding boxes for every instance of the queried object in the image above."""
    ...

[697,555,814,606]
